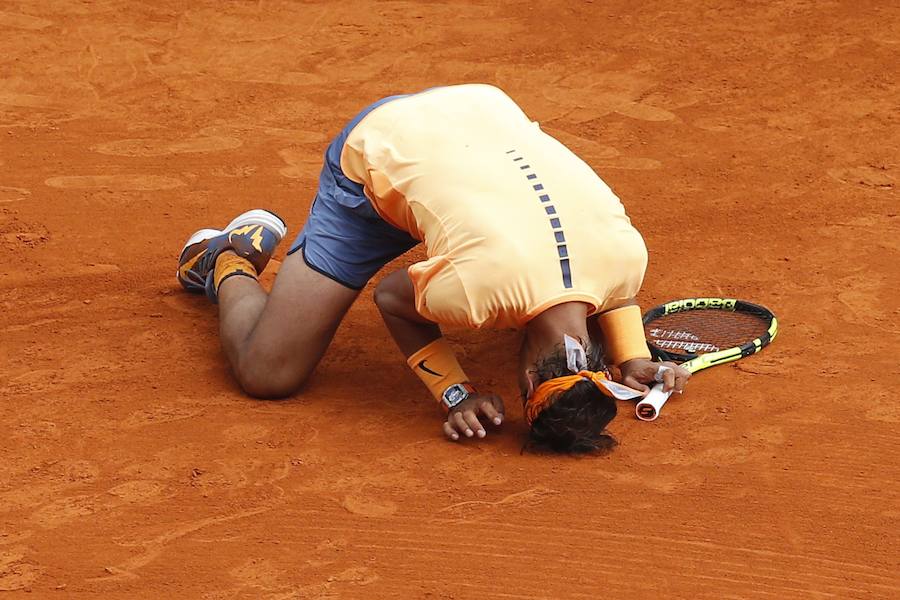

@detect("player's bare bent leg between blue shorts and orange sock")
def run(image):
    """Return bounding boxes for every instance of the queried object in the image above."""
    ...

[218,252,359,398]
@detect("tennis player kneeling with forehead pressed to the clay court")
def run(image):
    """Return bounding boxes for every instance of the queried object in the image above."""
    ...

[178,84,689,452]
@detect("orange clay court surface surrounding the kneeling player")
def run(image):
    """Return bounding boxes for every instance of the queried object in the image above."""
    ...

[0,0,900,600]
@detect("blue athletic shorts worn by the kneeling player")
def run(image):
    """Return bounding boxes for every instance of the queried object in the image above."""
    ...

[288,96,419,290]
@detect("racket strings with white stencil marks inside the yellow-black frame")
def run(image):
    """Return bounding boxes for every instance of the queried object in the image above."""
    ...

[644,310,769,355]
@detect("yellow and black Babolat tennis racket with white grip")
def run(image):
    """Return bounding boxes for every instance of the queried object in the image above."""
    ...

[635,298,778,421]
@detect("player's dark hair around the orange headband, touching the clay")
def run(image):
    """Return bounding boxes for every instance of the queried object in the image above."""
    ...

[526,342,617,454]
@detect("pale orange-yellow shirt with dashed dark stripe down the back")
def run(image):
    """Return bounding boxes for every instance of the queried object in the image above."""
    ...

[341,84,647,328]
